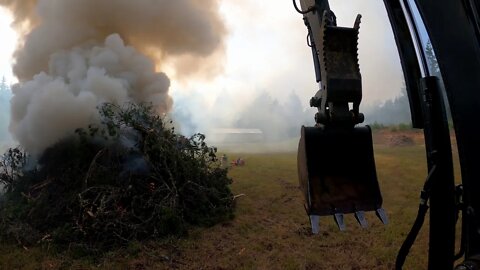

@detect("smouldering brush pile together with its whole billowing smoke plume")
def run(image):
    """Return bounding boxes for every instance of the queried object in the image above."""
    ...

[0,0,233,247]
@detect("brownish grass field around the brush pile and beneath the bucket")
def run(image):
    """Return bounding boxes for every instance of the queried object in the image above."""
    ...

[0,130,464,269]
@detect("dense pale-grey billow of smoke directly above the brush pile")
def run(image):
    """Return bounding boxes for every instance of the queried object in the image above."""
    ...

[10,34,172,153]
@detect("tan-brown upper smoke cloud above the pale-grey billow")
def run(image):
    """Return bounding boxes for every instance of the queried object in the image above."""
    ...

[0,0,225,80]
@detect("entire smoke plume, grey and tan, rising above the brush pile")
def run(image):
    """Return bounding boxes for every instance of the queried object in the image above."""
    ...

[0,0,225,153]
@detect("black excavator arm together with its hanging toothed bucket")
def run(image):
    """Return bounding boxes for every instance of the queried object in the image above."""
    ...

[294,0,388,233]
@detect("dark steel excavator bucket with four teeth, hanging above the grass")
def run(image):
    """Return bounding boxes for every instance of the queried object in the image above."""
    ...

[298,126,388,233]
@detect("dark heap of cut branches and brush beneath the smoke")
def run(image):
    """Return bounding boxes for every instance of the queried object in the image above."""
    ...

[0,104,234,249]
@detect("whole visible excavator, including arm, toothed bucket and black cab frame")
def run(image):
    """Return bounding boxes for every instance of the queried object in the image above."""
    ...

[293,0,480,270]
